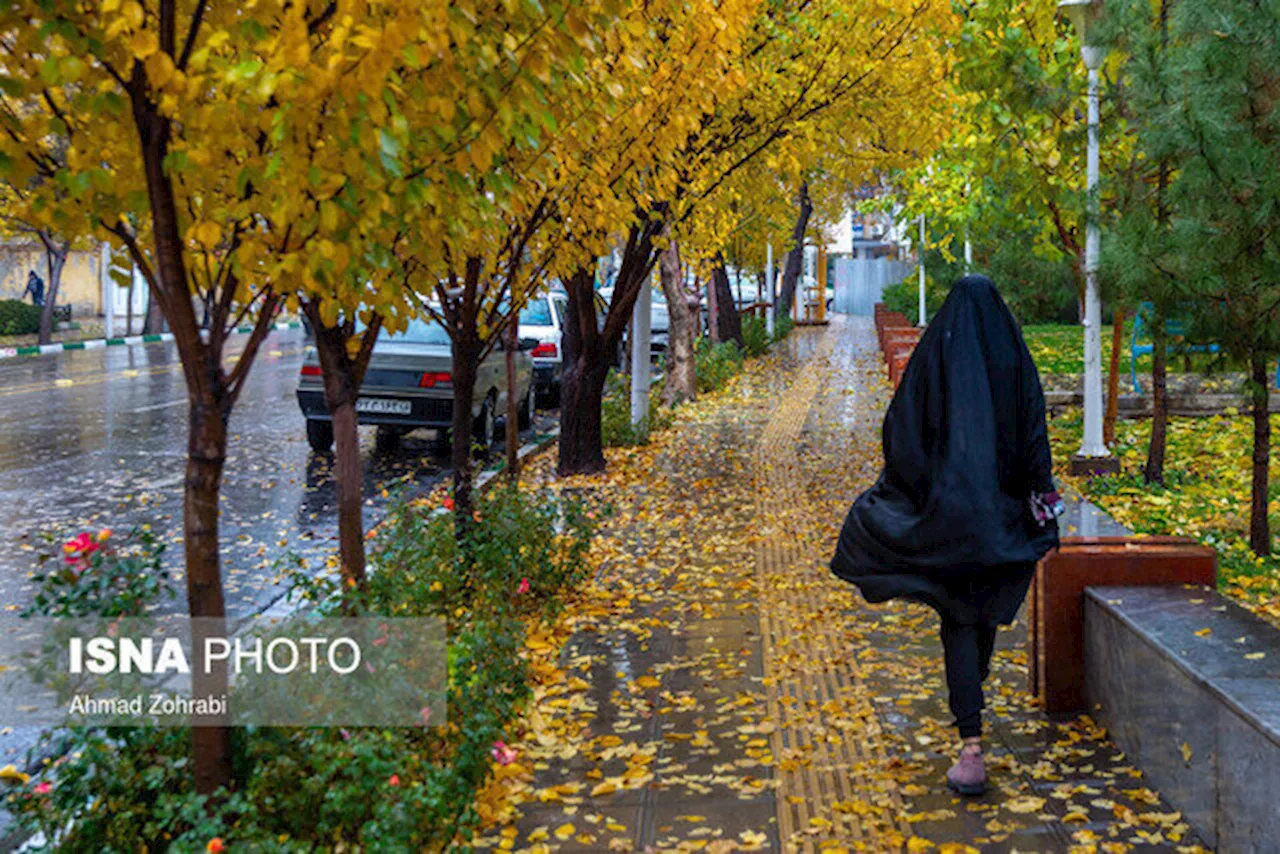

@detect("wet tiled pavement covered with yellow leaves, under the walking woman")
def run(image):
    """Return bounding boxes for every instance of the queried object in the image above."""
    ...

[479,319,1196,851]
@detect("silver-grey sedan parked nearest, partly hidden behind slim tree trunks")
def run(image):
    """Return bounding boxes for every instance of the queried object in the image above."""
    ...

[297,320,536,451]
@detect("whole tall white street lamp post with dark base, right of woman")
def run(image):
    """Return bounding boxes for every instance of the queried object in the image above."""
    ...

[1057,0,1120,474]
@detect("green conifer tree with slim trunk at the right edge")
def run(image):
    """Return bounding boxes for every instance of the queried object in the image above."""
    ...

[1125,0,1280,554]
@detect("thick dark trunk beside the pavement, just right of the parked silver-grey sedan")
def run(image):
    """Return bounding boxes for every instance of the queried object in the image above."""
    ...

[557,270,609,475]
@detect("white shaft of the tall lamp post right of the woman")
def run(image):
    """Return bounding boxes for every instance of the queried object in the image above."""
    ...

[1080,58,1110,457]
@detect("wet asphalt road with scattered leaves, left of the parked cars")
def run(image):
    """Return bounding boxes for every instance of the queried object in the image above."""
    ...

[0,329,550,615]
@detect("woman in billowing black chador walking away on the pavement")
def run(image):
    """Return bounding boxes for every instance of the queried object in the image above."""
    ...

[831,275,1062,794]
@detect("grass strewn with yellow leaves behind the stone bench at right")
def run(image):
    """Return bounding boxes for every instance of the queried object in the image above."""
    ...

[1050,411,1280,624]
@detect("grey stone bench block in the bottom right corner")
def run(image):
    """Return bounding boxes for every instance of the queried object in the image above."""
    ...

[1084,585,1280,853]
